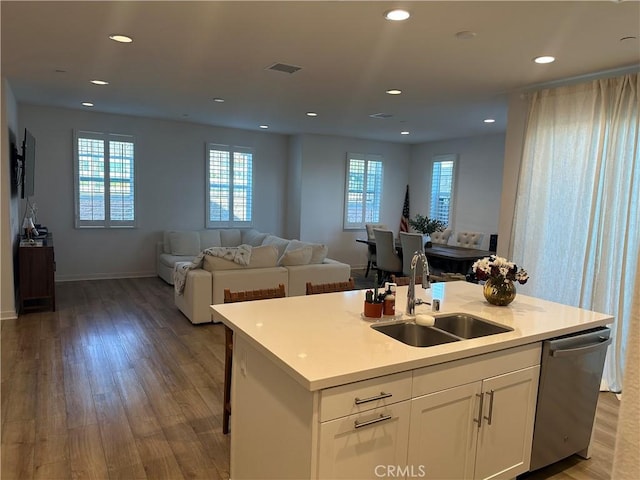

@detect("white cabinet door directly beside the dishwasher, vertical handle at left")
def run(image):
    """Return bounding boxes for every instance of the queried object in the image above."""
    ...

[474,366,540,479]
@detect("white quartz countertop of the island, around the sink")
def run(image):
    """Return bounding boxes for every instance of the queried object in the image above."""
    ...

[211,282,613,391]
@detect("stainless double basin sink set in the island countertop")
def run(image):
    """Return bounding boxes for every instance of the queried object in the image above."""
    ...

[371,313,513,347]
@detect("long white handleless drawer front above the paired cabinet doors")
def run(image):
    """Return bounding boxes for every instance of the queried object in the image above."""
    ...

[412,343,542,397]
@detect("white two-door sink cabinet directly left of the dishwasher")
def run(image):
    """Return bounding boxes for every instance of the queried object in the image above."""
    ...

[407,348,540,480]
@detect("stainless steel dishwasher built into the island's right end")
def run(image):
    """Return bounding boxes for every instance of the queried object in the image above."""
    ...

[529,327,611,471]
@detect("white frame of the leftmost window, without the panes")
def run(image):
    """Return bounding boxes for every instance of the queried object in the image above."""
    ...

[73,130,138,228]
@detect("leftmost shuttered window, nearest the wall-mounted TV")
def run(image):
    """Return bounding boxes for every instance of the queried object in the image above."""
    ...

[74,132,136,228]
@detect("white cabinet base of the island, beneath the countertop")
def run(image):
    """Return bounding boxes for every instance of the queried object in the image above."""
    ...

[231,336,540,480]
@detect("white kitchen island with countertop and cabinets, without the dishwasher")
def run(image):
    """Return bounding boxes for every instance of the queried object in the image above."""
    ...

[212,282,613,479]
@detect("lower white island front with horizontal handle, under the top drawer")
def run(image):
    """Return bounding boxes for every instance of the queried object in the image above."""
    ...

[318,400,410,479]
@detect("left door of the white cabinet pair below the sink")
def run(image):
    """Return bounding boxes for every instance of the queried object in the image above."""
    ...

[407,381,482,480]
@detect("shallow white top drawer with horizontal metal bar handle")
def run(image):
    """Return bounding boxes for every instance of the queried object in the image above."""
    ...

[320,371,412,422]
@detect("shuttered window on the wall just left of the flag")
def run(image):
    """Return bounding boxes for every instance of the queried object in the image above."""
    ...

[344,153,382,229]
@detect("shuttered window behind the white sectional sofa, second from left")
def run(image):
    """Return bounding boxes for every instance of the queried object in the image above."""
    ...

[206,144,253,228]
